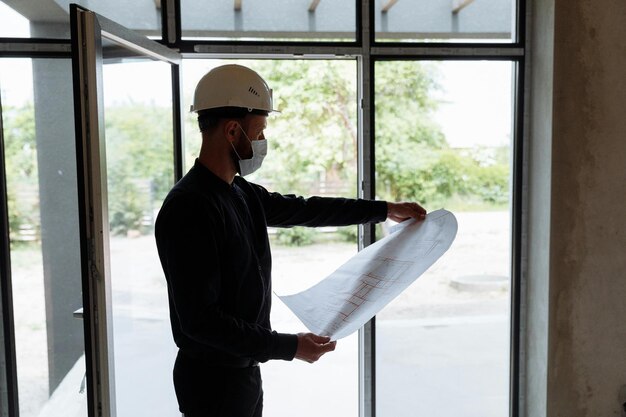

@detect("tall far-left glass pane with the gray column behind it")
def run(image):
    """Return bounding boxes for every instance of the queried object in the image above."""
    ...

[0,59,87,417]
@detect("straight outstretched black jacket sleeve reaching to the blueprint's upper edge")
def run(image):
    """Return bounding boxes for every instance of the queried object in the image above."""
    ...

[252,184,387,227]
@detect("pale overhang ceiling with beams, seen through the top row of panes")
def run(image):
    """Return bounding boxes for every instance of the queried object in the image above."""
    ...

[0,0,514,39]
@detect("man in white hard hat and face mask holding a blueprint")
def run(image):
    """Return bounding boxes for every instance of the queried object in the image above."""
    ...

[155,65,426,417]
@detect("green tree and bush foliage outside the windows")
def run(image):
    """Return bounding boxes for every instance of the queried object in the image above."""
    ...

[3,60,510,245]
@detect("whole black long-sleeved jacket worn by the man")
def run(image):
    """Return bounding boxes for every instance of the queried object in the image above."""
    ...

[155,161,387,365]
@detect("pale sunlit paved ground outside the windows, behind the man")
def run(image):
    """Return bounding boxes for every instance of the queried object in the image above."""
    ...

[41,213,509,417]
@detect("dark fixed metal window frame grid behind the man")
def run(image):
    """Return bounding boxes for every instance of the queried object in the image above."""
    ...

[0,0,529,417]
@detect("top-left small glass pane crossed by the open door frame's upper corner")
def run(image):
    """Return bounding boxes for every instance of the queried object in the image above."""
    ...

[0,0,161,39]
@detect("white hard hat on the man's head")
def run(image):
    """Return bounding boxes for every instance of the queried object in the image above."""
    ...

[190,64,277,112]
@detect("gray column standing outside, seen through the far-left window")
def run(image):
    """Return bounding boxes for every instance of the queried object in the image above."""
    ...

[33,59,84,393]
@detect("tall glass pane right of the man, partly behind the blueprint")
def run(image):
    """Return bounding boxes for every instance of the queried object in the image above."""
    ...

[375,62,512,417]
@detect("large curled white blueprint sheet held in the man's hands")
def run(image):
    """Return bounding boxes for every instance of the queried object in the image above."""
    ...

[279,210,458,340]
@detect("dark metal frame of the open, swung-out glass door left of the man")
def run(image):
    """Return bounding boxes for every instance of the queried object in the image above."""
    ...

[71,5,180,416]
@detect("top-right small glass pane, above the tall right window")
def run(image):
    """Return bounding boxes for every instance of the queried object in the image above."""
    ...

[374,0,517,42]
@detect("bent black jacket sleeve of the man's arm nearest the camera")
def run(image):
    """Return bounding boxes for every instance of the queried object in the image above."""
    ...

[155,196,297,362]
